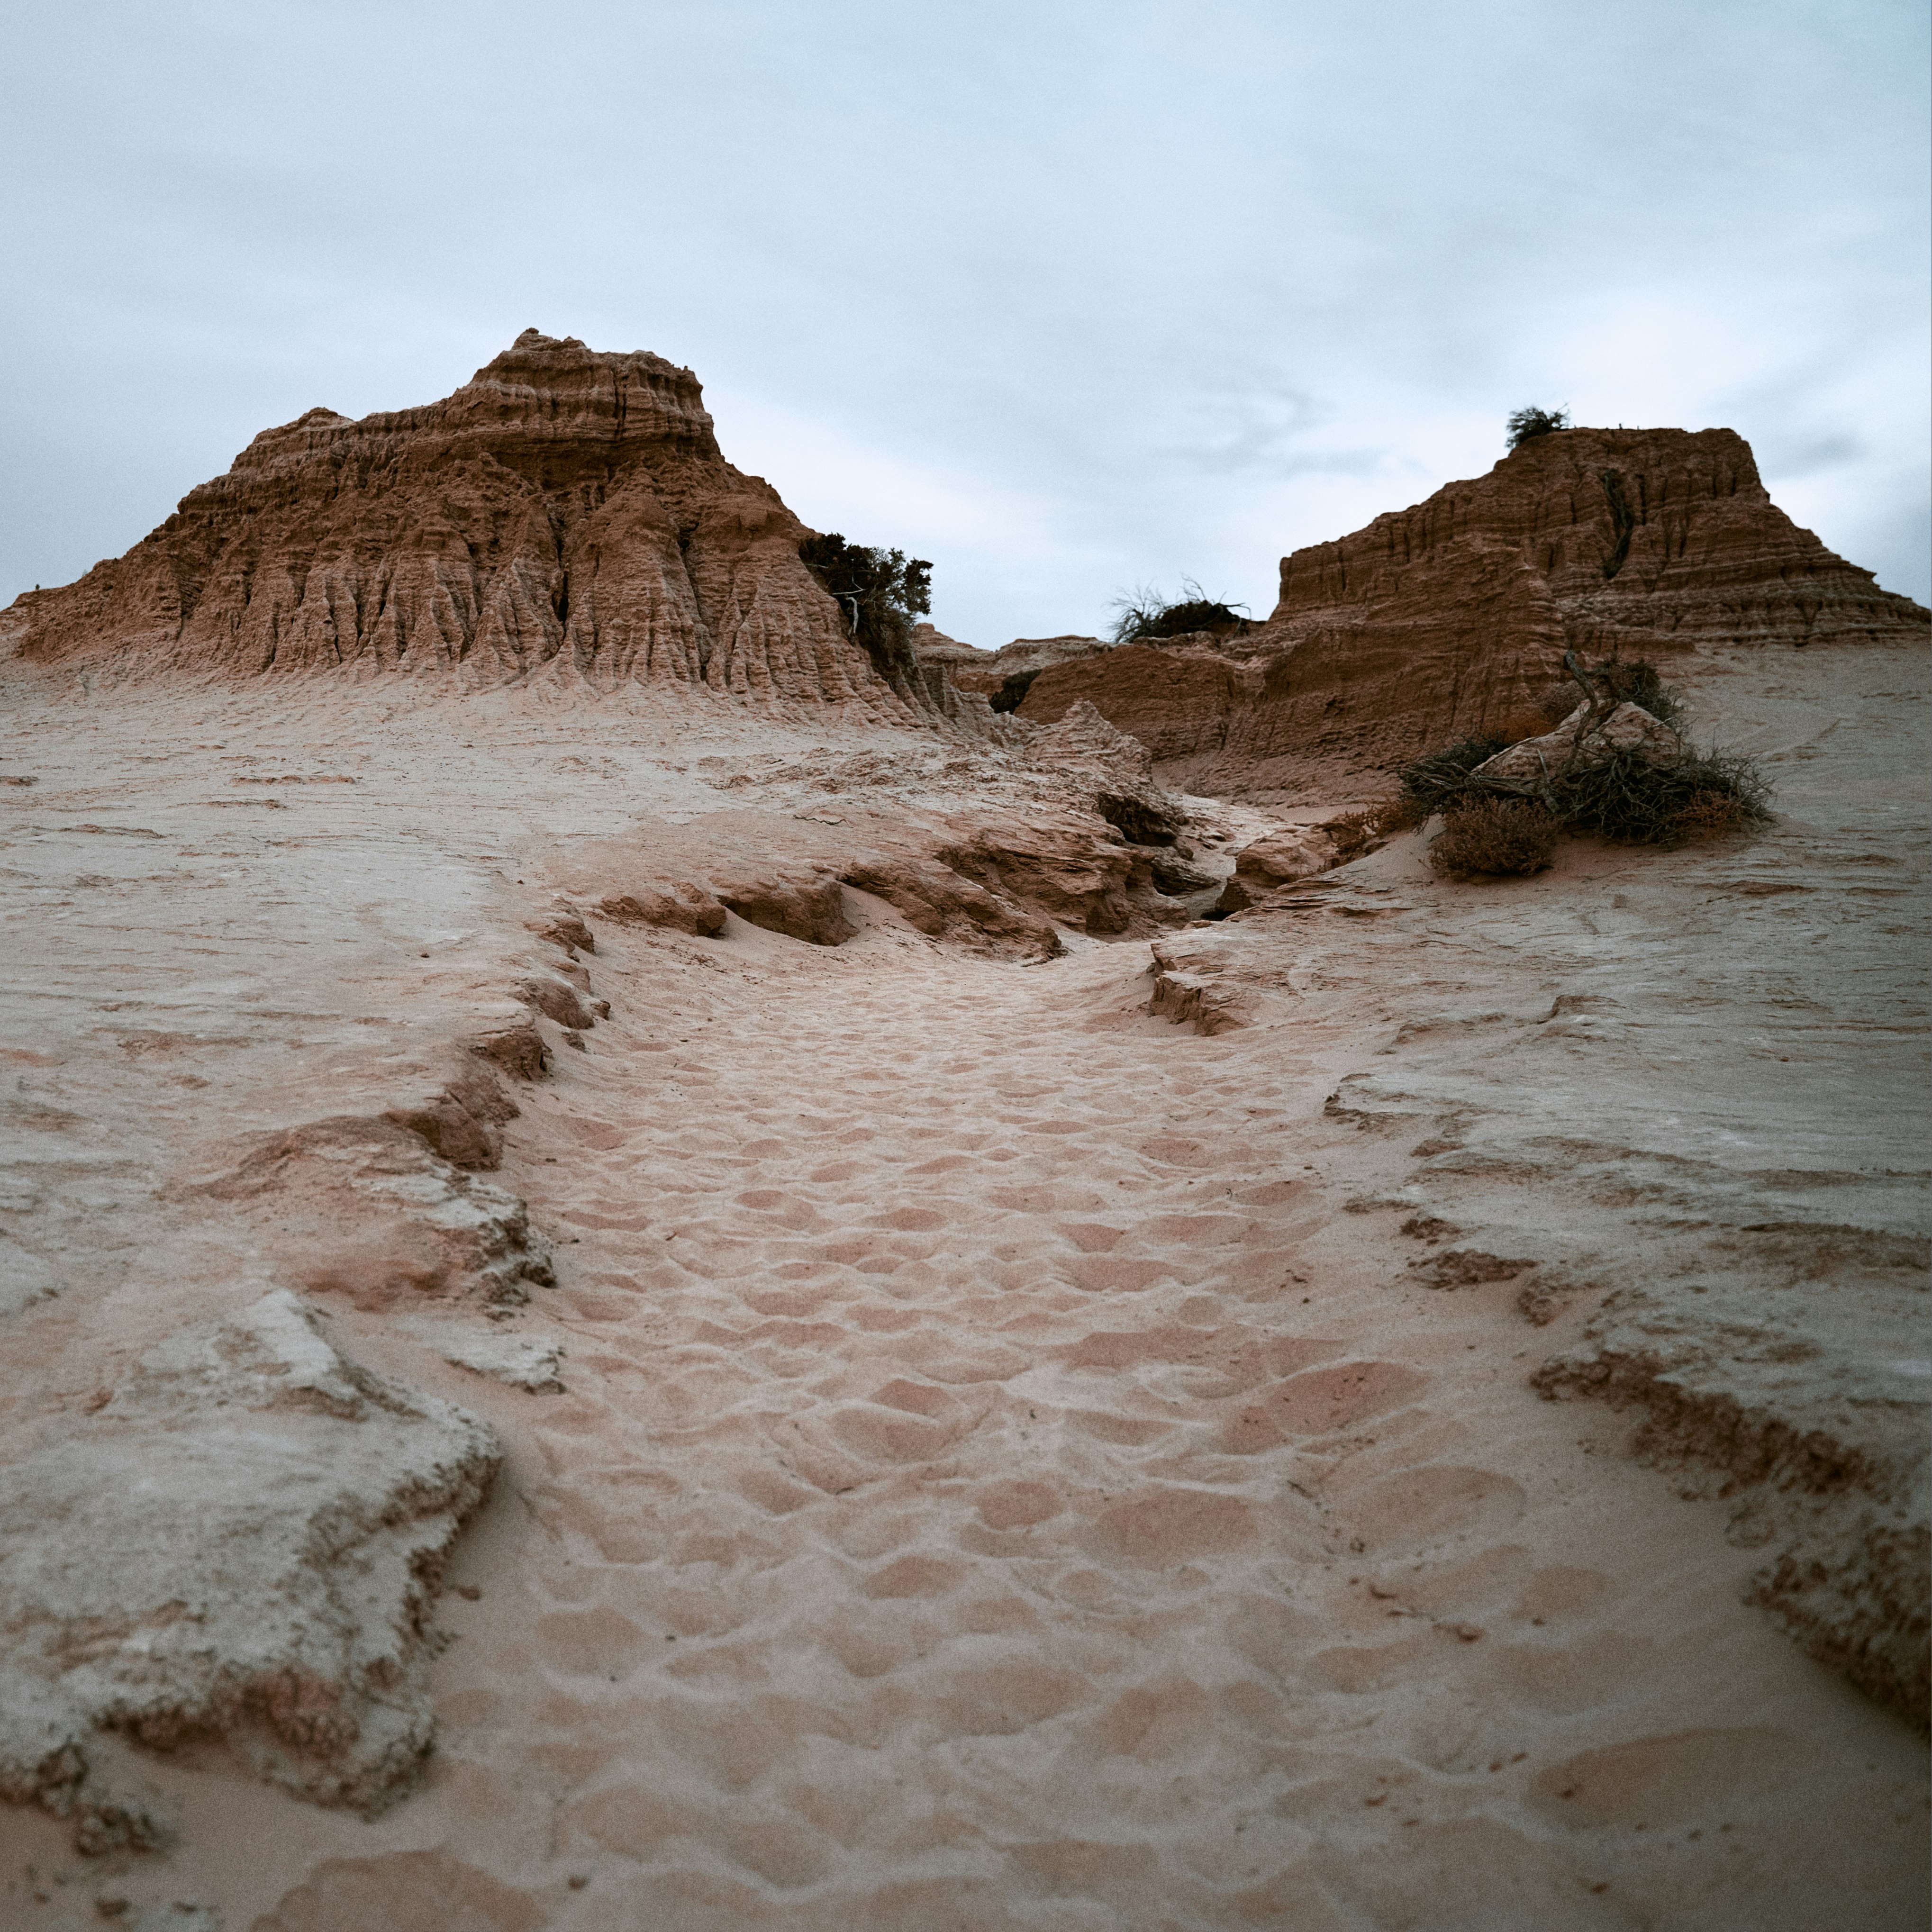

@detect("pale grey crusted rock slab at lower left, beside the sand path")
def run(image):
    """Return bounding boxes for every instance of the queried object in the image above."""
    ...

[0,1288,500,1851]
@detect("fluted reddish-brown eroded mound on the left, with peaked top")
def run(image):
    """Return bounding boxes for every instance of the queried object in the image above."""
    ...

[0,330,927,717]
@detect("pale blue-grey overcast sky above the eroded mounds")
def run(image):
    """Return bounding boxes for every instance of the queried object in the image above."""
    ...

[0,0,1932,645]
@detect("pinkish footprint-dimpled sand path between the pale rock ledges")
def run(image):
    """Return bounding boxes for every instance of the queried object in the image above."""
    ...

[109,908,1914,1928]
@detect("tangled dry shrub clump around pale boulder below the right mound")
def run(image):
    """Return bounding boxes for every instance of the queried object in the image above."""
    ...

[1376,659,1772,875]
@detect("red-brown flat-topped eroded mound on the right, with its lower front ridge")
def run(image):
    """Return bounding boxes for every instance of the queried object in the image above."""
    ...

[1020,429,1932,792]
